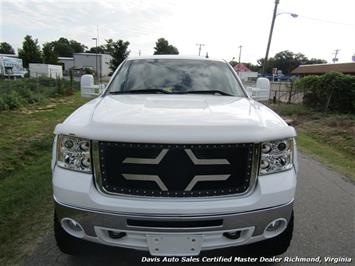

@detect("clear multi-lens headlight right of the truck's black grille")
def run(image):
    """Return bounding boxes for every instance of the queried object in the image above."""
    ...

[259,138,293,175]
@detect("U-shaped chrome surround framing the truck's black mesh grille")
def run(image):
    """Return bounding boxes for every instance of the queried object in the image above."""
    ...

[91,140,261,201]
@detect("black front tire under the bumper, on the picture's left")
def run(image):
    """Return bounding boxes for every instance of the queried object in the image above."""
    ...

[54,212,86,255]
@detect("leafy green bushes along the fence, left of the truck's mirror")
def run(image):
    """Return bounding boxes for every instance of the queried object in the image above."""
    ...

[0,77,79,110]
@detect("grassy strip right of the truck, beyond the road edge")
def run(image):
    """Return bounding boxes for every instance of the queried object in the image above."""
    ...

[270,104,355,181]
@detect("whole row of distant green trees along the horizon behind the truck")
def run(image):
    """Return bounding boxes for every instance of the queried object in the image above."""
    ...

[0,35,327,75]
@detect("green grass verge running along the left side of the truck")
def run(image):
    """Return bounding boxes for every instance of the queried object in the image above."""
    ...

[0,91,86,265]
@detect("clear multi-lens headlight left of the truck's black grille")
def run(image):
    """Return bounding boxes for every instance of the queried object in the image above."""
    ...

[57,135,91,173]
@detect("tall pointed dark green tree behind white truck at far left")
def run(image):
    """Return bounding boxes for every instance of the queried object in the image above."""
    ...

[18,35,42,67]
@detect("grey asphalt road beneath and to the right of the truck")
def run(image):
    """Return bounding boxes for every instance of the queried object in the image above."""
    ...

[24,154,355,266]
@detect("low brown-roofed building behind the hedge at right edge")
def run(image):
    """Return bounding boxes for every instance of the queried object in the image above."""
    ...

[291,62,355,76]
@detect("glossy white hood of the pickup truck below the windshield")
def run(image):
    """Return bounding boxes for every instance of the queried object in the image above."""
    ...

[55,95,296,144]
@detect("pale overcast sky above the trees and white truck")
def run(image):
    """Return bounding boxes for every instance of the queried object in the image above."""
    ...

[0,0,355,64]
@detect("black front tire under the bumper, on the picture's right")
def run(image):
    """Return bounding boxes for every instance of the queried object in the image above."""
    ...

[248,212,294,257]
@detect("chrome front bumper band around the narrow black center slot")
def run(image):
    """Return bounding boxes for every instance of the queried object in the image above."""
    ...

[54,198,293,236]
